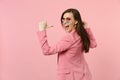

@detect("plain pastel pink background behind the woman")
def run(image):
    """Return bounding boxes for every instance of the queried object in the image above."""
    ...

[0,0,120,80]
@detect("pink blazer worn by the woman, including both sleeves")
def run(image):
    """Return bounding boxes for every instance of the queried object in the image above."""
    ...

[37,28,97,80]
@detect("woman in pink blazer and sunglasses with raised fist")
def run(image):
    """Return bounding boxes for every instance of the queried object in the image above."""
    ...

[38,8,97,80]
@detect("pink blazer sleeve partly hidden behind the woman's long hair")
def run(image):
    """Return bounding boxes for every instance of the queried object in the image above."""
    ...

[86,28,97,48]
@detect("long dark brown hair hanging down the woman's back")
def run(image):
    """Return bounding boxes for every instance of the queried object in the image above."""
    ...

[61,8,90,53]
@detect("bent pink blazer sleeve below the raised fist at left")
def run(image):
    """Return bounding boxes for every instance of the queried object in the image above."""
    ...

[37,30,73,55]
